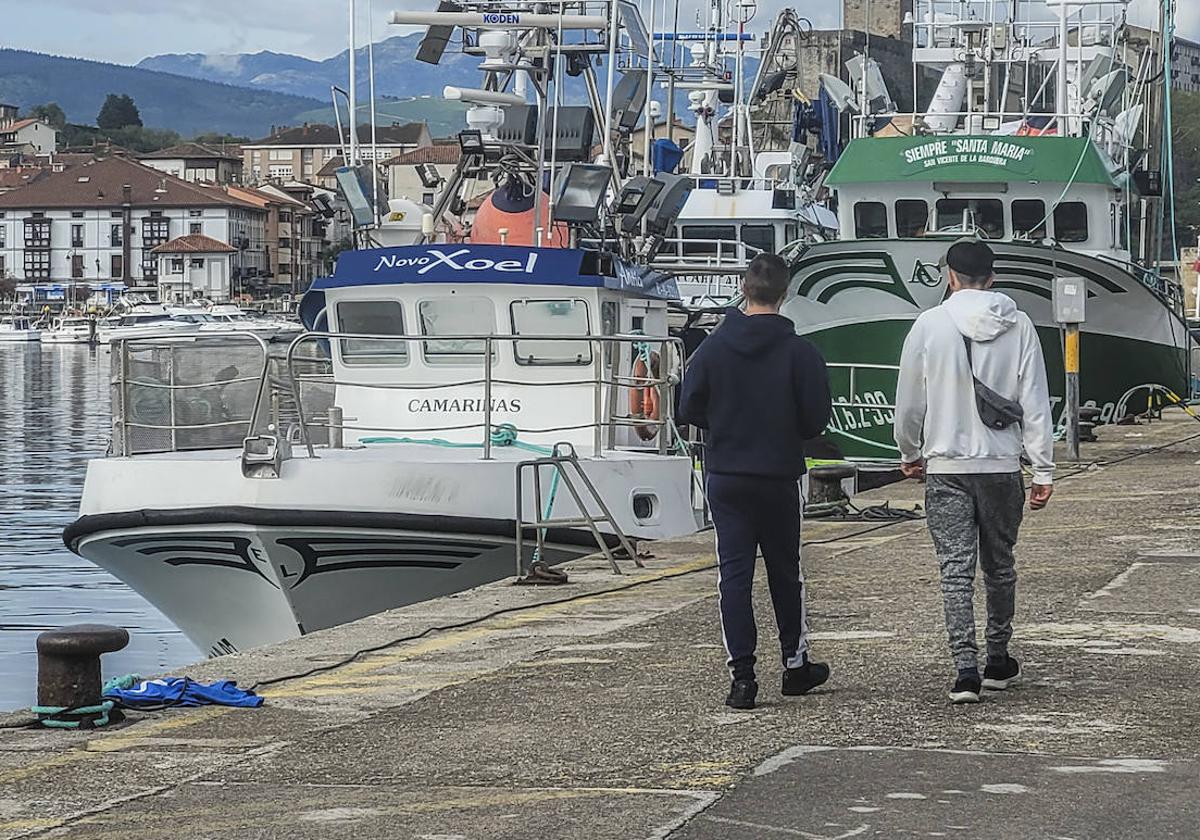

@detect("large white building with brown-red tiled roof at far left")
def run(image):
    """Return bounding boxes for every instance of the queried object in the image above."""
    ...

[0,157,268,292]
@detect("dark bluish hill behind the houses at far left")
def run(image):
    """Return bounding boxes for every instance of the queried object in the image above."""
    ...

[0,49,328,137]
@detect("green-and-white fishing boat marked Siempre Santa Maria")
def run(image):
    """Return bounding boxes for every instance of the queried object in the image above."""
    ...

[784,0,1190,462]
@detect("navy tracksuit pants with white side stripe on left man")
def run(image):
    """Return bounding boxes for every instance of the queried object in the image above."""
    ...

[708,473,808,679]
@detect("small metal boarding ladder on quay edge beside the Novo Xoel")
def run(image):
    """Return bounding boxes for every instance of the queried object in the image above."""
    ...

[516,443,644,577]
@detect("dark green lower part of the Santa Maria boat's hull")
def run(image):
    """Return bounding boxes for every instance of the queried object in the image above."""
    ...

[804,319,1187,460]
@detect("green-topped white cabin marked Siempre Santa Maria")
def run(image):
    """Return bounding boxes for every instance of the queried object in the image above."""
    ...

[826,134,1130,260]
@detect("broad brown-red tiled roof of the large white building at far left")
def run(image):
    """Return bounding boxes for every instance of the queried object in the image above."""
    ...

[0,157,254,210]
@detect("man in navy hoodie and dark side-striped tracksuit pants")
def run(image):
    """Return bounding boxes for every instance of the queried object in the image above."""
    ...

[679,254,830,709]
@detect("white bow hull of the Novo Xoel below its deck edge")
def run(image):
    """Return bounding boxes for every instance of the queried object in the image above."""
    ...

[74,509,589,656]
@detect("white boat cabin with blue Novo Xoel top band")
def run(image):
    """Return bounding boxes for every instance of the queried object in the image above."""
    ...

[301,245,679,454]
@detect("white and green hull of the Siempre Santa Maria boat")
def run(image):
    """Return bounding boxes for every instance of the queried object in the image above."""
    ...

[784,240,1190,461]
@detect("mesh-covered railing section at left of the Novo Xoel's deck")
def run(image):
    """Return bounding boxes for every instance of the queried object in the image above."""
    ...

[110,331,270,455]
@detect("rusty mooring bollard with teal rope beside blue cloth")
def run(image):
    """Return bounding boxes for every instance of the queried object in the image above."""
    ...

[34,624,130,728]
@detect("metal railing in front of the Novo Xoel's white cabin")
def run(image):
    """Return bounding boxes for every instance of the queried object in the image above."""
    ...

[273,332,684,460]
